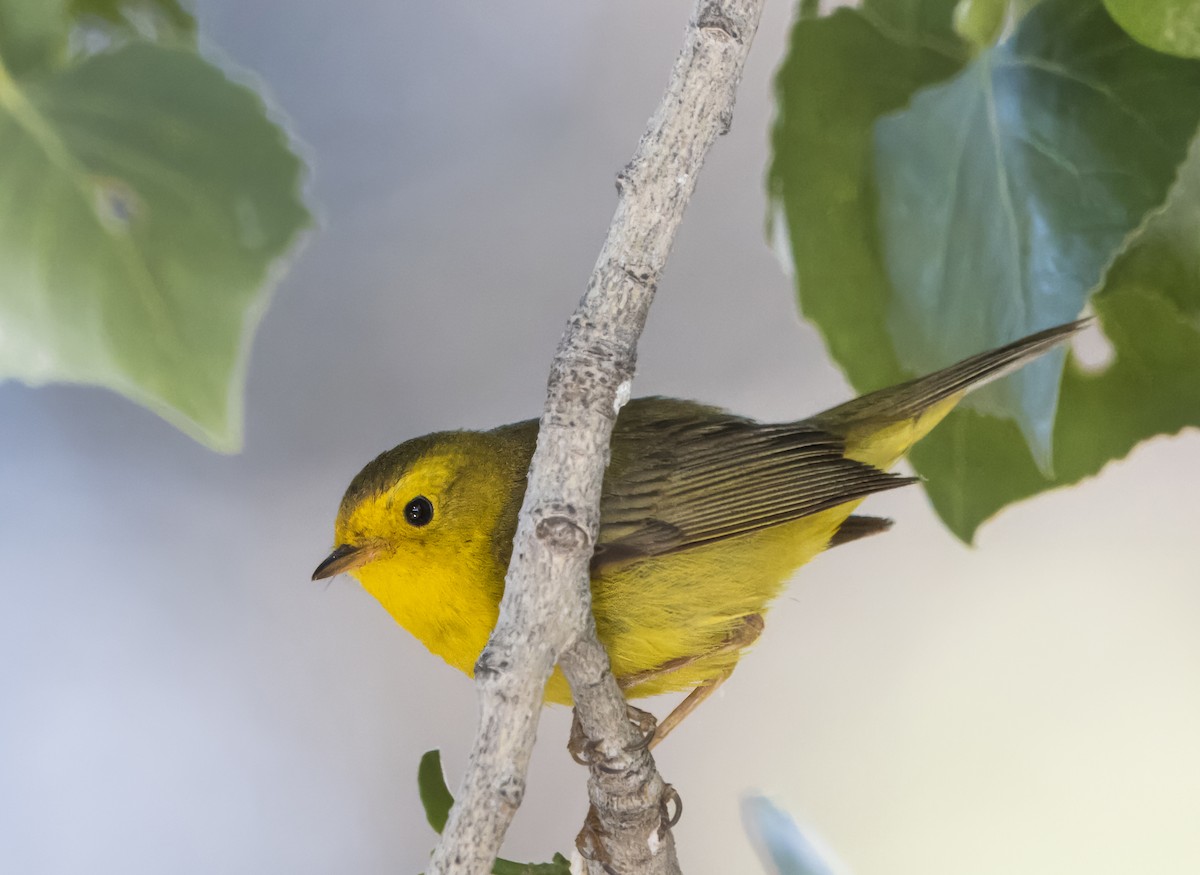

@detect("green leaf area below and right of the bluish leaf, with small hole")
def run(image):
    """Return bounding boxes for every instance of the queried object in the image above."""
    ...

[911,141,1200,541]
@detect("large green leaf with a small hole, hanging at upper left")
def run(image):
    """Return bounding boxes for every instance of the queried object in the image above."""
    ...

[0,42,310,450]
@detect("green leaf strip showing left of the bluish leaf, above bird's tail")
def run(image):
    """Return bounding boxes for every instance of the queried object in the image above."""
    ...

[768,0,968,390]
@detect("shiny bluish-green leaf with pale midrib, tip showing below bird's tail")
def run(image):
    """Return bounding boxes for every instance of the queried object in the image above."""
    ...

[875,0,1200,467]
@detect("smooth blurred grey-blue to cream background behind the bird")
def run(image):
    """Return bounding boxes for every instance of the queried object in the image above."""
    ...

[0,0,1200,875]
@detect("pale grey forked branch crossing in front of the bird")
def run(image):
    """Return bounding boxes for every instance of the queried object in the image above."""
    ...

[430,0,764,875]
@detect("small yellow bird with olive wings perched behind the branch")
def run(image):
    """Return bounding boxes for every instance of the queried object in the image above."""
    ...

[313,323,1081,703]
